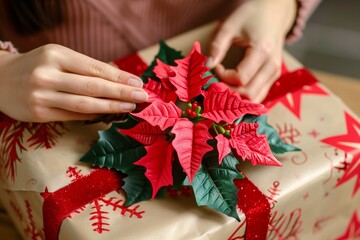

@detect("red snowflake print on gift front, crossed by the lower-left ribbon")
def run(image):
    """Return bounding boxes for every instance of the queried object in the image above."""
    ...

[66,167,145,234]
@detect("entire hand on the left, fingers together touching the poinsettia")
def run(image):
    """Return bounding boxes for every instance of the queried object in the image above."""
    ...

[0,44,148,122]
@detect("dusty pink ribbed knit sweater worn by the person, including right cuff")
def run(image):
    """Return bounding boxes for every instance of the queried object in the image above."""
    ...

[0,0,320,61]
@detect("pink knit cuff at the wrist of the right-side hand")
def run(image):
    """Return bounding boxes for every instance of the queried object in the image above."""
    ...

[286,0,321,43]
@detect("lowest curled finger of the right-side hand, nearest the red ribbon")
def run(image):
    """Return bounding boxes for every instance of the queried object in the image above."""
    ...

[239,60,280,102]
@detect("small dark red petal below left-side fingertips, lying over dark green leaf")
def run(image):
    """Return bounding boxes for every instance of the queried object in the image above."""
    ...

[118,122,165,145]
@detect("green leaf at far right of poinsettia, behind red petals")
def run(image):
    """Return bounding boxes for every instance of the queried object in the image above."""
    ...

[242,115,301,154]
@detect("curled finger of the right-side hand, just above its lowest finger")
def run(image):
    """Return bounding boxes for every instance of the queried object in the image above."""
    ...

[236,47,267,86]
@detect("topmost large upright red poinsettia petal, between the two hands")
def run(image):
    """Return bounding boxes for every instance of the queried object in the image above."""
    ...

[169,44,211,102]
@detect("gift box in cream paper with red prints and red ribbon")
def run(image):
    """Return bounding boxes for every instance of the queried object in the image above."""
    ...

[0,25,360,240]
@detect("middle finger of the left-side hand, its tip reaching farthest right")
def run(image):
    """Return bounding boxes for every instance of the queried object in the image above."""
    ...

[51,73,148,103]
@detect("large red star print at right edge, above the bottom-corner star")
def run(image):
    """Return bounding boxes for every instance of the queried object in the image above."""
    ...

[321,112,360,195]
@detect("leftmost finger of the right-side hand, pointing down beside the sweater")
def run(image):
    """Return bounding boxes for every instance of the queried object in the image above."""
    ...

[206,22,235,68]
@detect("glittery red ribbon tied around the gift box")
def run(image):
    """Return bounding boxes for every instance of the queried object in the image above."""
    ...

[43,54,316,240]
